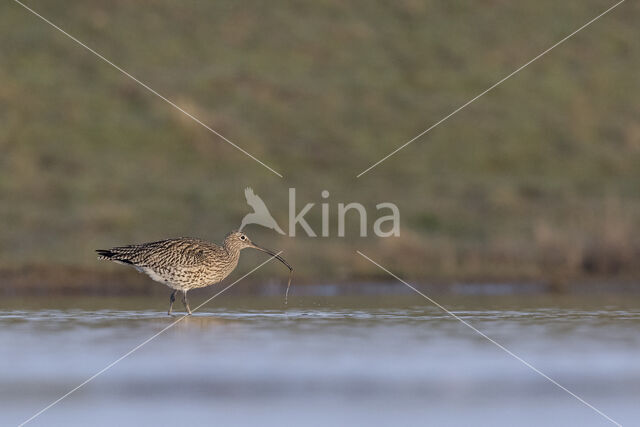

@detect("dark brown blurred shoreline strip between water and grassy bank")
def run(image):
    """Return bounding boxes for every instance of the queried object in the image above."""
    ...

[0,265,640,297]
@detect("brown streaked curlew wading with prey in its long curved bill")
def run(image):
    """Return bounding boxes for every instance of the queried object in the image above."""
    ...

[96,231,293,315]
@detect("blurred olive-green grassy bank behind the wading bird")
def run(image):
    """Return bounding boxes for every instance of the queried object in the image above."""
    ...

[0,0,640,288]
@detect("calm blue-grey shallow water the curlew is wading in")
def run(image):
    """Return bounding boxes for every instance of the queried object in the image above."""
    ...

[0,295,640,426]
